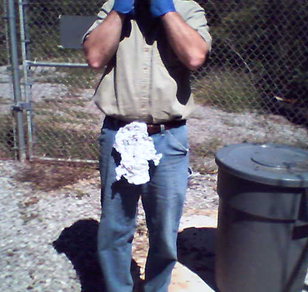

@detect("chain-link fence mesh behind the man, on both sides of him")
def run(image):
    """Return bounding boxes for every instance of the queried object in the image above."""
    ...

[0,0,308,161]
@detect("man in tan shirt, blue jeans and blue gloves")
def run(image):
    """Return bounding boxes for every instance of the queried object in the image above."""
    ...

[83,0,211,292]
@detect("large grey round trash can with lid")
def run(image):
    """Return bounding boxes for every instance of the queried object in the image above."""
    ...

[215,143,308,292]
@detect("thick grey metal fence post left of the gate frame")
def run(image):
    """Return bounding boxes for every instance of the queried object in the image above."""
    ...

[8,0,26,162]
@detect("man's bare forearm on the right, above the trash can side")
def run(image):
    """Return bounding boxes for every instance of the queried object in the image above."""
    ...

[161,12,209,70]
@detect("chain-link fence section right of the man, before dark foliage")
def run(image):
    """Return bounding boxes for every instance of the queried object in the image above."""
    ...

[194,0,308,123]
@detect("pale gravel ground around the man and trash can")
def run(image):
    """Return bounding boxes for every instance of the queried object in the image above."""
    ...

[0,107,308,292]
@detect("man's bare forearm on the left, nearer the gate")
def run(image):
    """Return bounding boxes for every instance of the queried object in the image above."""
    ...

[83,11,125,69]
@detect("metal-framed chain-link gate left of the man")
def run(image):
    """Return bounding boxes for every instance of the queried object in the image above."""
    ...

[0,0,102,162]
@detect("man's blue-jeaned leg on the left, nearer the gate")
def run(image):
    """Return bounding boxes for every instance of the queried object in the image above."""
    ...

[98,123,139,292]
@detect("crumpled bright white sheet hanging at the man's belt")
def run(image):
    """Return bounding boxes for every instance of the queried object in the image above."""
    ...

[113,122,162,185]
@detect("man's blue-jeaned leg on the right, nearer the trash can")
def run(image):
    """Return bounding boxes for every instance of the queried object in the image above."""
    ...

[143,126,188,292]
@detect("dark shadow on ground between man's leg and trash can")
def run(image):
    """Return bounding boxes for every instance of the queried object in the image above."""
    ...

[177,227,217,291]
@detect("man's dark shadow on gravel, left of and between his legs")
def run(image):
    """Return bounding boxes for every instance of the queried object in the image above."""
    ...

[53,219,141,292]
